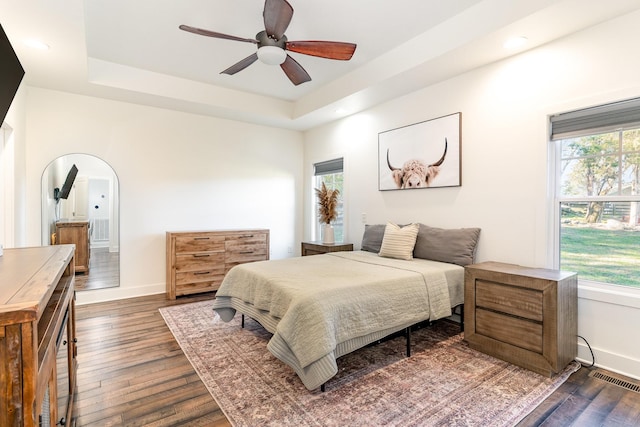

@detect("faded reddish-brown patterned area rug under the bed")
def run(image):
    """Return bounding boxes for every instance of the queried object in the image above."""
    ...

[160,301,580,426]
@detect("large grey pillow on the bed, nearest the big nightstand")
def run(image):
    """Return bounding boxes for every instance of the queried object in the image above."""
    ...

[413,224,480,266]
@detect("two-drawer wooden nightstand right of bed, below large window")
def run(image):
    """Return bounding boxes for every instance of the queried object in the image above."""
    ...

[464,262,578,376]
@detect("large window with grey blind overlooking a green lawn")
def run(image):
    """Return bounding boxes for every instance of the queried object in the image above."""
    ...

[551,99,640,289]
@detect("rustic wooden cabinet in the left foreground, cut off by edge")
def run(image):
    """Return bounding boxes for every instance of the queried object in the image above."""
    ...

[0,245,77,426]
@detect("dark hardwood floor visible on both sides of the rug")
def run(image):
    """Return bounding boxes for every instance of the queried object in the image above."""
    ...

[75,294,640,427]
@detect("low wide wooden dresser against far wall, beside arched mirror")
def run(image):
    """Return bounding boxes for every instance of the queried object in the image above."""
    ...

[167,230,269,299]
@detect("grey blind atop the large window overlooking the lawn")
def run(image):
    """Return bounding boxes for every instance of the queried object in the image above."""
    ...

[551,98,640,141]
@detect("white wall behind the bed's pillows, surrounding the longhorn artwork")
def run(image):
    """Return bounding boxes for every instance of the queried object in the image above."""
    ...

[304,12,640,377]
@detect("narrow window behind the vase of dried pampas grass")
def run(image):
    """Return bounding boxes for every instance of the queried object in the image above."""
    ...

[313,158,344,242]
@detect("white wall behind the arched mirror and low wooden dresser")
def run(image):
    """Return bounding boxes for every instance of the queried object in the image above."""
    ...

[26,87,303,303]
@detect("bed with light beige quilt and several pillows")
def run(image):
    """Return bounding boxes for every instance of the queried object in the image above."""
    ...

[214,224,479,390]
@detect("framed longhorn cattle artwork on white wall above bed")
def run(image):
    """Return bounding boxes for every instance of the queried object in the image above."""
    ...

[378,113,462,191]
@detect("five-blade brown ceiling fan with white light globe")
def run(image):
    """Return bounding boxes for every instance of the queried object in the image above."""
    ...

[179,0,356,86]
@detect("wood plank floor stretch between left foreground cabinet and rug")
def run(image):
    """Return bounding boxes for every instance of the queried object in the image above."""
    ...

[75,294,230,426]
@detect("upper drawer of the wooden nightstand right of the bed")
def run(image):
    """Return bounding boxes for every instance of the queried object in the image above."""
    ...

[476,279,543,322]
